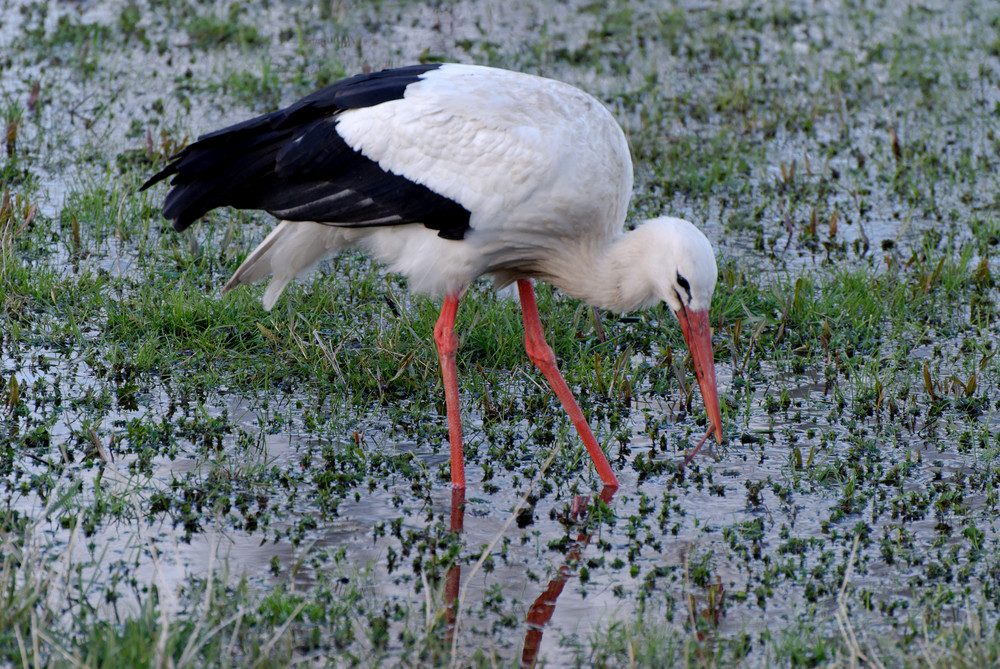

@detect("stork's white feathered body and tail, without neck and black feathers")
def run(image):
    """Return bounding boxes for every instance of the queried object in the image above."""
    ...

[226,64,632,308]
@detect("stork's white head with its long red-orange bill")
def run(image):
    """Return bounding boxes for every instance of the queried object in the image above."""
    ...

[642,217,722,443]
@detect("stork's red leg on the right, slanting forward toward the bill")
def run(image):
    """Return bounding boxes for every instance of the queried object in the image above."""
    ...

[517,279,618,488]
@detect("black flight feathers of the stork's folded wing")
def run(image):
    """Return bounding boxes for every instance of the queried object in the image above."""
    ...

[141,65,469,239]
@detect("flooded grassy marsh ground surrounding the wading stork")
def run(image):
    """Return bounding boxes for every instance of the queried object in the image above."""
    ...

[0,0,1000,666]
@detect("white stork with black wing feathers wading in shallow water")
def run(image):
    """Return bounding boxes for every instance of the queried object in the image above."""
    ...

[142,64,722,488]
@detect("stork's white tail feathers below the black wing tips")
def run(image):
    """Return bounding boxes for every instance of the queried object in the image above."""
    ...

[222,221,351,311]
